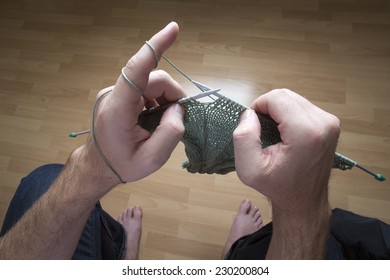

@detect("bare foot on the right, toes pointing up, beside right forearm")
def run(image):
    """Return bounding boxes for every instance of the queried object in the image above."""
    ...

[221,199,263,259]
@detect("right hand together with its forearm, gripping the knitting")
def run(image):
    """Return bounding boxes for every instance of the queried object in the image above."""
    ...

[233,89,340,259]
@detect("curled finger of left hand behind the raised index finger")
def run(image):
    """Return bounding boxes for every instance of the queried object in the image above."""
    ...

[145,70,186,104]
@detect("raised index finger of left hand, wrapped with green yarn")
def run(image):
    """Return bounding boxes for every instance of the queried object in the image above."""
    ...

[114,22,179,105]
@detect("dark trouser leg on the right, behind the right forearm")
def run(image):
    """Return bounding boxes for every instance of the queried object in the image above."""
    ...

[226,209,390,260]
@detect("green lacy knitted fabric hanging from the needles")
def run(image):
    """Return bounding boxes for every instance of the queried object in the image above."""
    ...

[138,97,352,174]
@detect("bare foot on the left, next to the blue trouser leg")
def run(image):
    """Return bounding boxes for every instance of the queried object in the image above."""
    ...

[118,206,142,260]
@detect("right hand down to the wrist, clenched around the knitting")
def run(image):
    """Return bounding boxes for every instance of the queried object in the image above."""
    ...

[234,89,340,219]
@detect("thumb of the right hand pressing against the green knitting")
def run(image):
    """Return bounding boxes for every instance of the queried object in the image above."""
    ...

[233,110,263,187]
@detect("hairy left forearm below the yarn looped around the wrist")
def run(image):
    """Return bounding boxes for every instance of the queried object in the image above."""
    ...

[0,145,114,259]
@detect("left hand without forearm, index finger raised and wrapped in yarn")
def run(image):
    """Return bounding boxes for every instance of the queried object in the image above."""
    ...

[83,23,185,186]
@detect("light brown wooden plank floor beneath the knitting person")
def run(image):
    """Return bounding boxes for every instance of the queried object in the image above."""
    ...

[0,0,390,259]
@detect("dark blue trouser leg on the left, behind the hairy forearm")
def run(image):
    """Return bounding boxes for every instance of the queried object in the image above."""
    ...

[0,164,126,260]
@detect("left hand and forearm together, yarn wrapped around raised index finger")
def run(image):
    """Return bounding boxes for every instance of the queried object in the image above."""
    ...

[0,23,185,259]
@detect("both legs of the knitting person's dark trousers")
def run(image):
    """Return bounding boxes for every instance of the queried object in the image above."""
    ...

[0,164,390,259]
